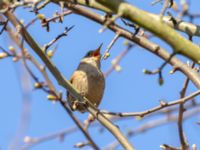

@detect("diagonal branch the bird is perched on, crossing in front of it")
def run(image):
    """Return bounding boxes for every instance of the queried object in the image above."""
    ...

[4,11,133,150]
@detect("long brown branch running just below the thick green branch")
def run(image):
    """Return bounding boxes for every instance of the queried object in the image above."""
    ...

[59,5,200,88]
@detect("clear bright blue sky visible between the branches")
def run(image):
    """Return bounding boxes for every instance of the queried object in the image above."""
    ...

[0,0,200,150]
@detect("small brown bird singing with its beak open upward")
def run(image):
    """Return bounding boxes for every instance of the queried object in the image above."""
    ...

[67,44,105,113]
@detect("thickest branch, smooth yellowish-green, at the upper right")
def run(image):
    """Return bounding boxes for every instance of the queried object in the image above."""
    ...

[59,0,200,63]
